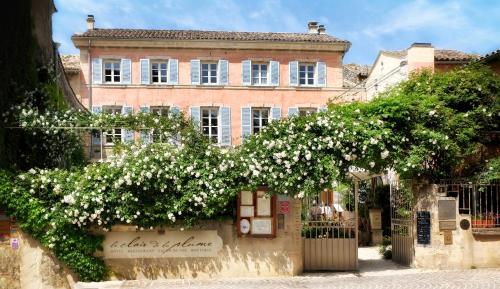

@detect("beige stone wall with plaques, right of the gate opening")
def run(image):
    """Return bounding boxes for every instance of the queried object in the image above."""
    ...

[414,185,500,269]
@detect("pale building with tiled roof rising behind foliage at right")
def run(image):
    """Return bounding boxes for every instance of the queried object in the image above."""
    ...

[365,43,480,100]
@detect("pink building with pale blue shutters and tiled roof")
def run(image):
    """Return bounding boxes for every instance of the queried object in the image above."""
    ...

[72,15,351,156]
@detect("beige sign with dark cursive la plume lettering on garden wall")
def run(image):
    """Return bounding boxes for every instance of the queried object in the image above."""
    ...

[103,230,222,259]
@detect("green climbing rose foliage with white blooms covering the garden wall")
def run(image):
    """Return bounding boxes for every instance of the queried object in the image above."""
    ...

[0,66,500,280]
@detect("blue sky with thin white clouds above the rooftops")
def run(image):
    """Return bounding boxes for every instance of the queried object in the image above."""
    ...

[53,0,500,64]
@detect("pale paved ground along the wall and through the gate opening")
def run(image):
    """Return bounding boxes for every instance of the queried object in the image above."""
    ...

[77,248,500,289]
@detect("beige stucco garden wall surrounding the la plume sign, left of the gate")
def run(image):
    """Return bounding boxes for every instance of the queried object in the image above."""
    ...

[101,199,303,280]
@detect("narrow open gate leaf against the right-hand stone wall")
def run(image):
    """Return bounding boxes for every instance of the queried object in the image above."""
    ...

[391,181,415,266]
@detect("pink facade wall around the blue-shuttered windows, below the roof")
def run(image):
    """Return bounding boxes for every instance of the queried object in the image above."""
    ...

[80,48,351,145]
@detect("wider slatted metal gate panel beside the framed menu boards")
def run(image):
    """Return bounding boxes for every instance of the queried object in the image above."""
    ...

[302,182,358,271]
